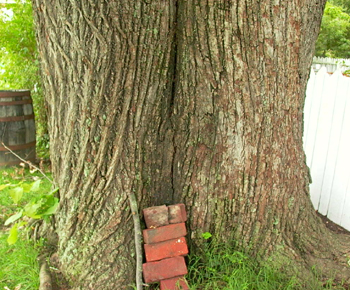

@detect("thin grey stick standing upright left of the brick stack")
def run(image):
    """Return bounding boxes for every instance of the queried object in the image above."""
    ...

[129,192,143,290]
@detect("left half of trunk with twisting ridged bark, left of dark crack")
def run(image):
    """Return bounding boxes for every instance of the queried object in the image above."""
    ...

[34,0,175,289]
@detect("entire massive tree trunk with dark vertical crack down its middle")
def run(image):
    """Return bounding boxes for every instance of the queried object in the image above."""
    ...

[33,0,348,289]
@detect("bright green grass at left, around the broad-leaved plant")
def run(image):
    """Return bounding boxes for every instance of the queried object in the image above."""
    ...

[0,167,51,290]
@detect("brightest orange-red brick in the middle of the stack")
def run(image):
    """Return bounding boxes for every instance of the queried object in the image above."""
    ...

[144,237,188,262]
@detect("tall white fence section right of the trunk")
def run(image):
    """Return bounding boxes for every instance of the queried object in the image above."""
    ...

[304,67,350,230]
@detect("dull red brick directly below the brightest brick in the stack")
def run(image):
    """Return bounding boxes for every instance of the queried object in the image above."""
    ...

[142,256,187,283]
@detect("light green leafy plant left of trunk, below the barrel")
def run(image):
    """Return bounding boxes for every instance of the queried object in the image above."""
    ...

[0,179,58,244]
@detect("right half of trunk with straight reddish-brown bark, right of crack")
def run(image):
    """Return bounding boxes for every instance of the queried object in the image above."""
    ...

[173,1,350,279]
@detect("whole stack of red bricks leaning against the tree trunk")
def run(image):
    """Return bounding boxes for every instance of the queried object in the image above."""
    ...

[143,204,189,290]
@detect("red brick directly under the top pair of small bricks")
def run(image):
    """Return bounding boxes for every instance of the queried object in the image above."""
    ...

[143,223,187,244]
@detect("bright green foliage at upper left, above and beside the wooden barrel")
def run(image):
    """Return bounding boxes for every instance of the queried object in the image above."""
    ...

[0,0,48,157]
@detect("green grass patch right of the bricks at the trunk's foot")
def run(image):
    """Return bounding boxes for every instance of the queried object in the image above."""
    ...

[187,244,347,290]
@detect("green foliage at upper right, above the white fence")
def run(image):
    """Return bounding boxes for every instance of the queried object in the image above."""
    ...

[315,2,350,58]
